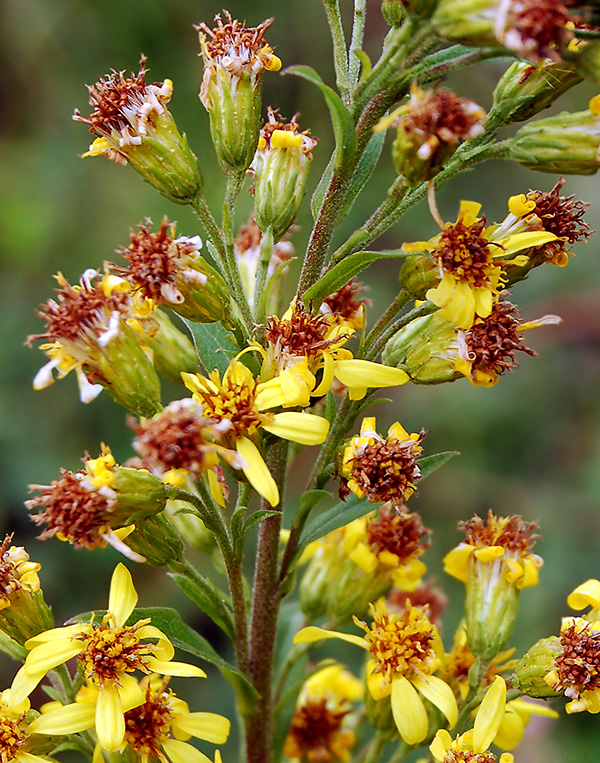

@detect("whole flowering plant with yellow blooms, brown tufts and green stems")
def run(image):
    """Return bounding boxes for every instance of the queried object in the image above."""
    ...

[0,0,600,763]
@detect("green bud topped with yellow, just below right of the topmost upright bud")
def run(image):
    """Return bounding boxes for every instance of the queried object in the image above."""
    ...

[249,109,317,240]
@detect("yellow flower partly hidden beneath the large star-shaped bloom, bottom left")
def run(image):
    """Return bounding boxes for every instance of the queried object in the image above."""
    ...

[34,675,231,763]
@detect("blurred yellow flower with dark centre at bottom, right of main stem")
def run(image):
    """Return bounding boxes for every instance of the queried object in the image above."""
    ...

[284,663,362,763]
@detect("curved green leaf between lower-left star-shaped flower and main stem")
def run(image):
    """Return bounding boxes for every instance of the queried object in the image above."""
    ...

[128,607,258,712]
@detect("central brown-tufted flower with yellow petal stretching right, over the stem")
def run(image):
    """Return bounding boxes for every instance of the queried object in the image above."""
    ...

[255,302,408,407]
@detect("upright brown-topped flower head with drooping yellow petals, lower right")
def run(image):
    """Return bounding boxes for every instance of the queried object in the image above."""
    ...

[444,509,543,659]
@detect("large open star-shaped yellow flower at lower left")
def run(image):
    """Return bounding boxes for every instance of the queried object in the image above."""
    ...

[11,564,206,750]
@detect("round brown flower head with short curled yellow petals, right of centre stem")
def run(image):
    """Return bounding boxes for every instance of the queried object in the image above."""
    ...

[339,417,425,507]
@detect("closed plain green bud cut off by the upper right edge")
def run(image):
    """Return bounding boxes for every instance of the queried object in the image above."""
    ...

[508,96,600,175]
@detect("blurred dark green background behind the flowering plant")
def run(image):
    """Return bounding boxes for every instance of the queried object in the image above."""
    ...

[0,0,600,763]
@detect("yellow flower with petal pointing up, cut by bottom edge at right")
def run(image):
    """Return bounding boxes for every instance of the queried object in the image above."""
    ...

[429,676,513,763]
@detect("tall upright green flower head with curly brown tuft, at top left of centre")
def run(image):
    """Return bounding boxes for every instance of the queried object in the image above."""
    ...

[196,11,281,172]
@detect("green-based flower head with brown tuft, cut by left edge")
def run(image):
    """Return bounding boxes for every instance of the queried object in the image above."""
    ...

[0,535,54,646]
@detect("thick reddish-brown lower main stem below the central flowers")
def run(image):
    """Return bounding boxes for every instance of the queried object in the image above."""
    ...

[246,442,287,763]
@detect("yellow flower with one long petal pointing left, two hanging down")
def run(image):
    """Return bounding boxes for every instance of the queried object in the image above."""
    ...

[294,600,458,744]
